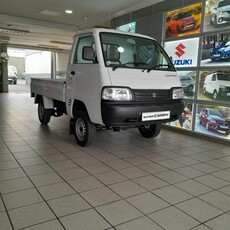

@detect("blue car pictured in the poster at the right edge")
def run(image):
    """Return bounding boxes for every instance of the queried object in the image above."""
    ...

[210,40,230,61]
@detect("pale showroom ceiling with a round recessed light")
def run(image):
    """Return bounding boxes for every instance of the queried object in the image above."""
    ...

[0,0,164,50]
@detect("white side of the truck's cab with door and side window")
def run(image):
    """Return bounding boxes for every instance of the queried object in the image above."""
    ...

[66,34,101,123]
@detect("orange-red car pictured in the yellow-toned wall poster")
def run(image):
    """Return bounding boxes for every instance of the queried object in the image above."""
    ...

[168,12,196,33]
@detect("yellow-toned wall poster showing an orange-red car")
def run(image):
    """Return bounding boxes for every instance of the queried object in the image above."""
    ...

[165,3,202,38]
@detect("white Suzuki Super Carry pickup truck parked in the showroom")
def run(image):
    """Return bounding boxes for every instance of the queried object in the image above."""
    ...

[31,28,183,147]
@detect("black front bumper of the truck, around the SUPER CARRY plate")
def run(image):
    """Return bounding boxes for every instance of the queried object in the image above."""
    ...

[101,100,184,127]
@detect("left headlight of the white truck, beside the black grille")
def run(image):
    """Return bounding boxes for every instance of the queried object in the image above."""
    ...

[101,88,132,101]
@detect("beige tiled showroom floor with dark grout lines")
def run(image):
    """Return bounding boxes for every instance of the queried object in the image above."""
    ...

[0,87,230,230]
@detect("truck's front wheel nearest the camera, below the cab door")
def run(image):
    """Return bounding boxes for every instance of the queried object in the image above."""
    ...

[74,111,96,147]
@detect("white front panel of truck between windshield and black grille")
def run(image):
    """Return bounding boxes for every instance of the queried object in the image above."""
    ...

[108,68,181,89]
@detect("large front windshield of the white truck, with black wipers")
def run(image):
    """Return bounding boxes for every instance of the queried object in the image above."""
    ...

[100,32,175,71]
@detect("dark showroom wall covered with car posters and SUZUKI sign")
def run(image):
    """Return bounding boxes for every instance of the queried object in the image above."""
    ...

[112,0,230,142]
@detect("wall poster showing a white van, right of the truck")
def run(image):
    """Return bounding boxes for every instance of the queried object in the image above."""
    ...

[198,69,230,104]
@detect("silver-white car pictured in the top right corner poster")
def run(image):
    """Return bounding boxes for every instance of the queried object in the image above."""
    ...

[211,0,230,25]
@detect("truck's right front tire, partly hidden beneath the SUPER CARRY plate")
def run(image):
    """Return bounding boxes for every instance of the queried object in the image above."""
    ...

[138,124,161,138]
